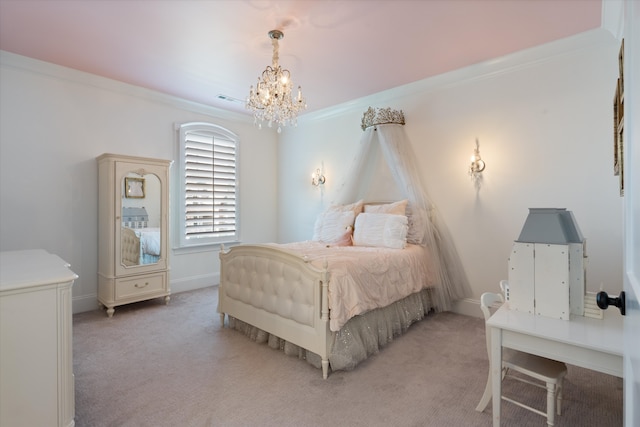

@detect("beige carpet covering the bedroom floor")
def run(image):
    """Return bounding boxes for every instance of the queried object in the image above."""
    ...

[73,287,622,427]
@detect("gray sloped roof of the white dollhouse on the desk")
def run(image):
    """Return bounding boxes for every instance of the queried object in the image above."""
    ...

[516,208,584,245]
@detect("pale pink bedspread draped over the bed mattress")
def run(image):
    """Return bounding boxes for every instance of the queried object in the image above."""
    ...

[275,241,435,331]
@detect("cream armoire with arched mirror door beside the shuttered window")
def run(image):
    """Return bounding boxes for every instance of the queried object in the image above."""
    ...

[97,154,171,317]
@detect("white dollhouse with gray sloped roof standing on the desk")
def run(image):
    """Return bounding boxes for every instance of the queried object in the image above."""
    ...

[507,208,585,320]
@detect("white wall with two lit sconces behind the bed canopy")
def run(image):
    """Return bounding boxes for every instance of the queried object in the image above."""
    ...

[279,30,622,312]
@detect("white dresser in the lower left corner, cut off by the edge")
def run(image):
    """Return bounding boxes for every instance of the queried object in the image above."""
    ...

[0,249,78,427]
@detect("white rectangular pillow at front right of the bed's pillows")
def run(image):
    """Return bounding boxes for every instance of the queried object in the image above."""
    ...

[353,213,409,249]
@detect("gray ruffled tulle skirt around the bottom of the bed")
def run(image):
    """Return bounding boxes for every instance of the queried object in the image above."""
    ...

[229,289,434,371]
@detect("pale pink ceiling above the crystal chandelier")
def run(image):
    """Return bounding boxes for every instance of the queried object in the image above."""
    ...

[0,0,602,116]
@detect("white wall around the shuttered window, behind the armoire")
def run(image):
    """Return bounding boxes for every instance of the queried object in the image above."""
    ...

[0,52,277,312]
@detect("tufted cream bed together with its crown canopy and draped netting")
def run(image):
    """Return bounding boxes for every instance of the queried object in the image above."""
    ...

[218,108,470,378]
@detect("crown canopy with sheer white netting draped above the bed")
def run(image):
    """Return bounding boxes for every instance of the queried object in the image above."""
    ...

[335,107,469,310]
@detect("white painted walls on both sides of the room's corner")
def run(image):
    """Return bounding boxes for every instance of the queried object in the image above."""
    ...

[0,30,622,312]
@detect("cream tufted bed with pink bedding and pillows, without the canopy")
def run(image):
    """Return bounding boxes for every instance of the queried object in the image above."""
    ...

[218,201,442,379]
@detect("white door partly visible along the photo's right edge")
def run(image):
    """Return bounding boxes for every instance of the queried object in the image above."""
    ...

[623,0,640,426]
